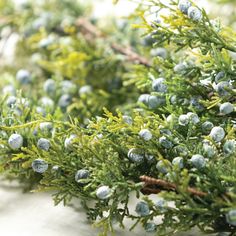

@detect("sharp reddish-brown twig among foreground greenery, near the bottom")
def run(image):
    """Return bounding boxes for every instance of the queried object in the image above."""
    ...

[140,175,207,197]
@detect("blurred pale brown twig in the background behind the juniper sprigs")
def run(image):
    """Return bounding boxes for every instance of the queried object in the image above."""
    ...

[77,18,151,67]
